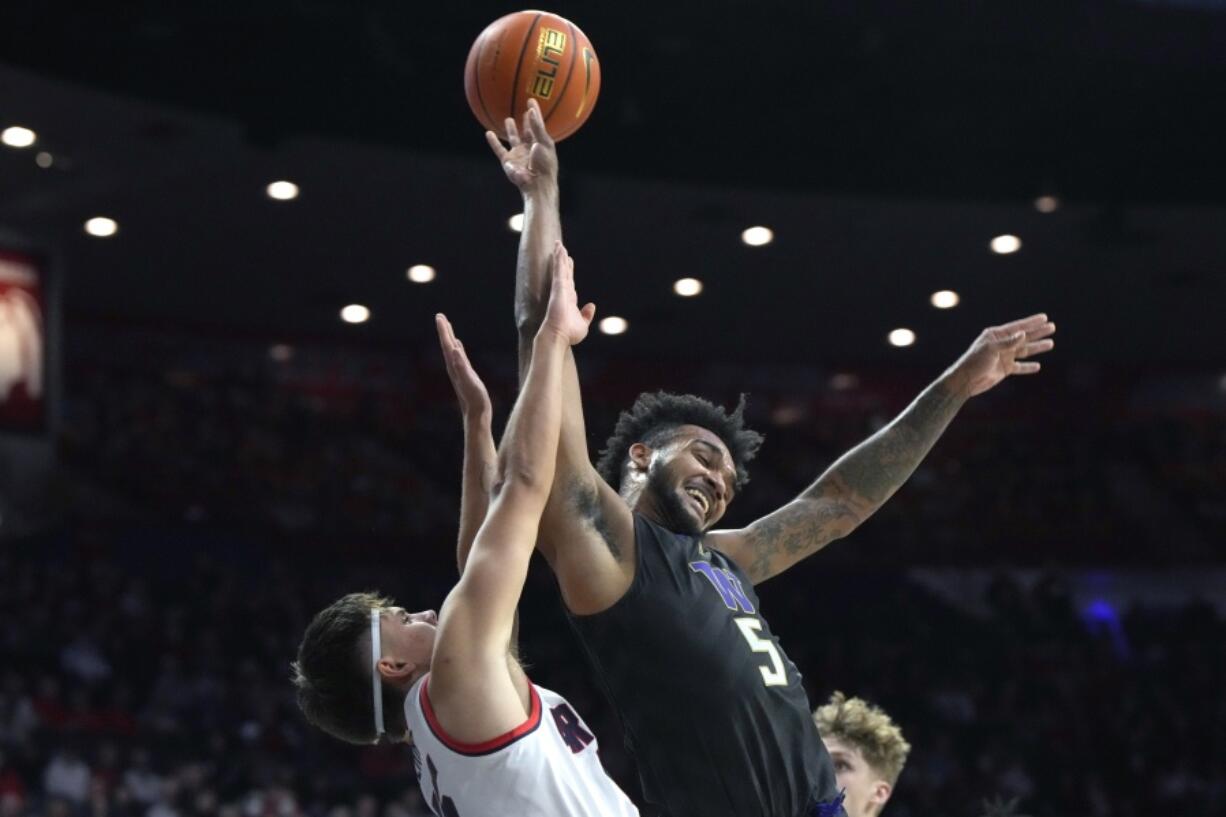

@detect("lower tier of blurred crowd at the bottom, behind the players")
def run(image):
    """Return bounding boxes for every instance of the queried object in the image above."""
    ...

[0,539,1226,817]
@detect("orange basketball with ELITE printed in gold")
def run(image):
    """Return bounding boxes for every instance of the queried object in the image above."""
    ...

[463,11,601,141]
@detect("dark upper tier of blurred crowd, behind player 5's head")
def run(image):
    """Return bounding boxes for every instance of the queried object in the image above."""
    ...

[47,321,1226,566]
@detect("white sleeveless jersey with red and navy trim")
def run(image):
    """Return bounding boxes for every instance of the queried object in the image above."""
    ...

[405,675,639,817]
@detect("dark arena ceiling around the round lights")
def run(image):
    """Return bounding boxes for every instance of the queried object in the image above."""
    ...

[0,0,1226,364]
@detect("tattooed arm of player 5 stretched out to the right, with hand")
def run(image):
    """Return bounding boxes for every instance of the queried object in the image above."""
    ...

[707,314,1056,583]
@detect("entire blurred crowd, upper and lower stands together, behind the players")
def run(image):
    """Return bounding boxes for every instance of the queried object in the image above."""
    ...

[0,323,1226,817]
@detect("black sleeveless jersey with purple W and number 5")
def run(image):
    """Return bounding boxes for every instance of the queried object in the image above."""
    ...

[571,514,846,817]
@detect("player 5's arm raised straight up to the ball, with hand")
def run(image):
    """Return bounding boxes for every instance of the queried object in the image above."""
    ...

[485,99,634,613]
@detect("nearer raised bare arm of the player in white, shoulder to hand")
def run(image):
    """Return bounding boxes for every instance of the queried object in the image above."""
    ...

[430,244,595,734]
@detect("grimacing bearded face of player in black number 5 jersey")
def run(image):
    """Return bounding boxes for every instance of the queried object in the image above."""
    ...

[647,426,737,536]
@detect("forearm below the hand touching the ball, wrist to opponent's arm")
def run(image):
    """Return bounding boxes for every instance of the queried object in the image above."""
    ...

[515,183,562,383]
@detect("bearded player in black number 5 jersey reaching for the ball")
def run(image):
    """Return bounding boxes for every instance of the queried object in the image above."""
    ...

[485,101,1056,817]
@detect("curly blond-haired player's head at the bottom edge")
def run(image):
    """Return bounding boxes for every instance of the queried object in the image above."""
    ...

[813,692,911,817]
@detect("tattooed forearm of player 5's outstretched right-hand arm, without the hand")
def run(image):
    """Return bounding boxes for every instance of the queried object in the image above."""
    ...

[801,372,969,515]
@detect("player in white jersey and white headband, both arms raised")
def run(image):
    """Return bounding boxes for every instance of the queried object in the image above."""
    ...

[294,243,638,817]
